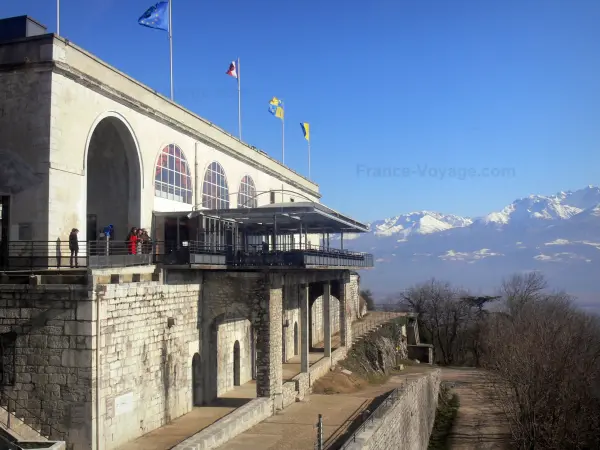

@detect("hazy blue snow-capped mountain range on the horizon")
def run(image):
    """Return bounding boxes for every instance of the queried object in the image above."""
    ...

[345,185,600,306]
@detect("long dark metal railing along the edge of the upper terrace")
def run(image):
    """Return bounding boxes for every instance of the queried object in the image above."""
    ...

[0,241,373,270]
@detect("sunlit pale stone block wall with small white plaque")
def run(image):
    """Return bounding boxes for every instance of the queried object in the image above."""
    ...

[92,282,201,449]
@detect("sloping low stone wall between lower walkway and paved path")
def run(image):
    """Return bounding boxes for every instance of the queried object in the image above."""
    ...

[345,369,441,450]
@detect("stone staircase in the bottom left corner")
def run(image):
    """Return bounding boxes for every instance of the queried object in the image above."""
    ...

[0,392,67,450]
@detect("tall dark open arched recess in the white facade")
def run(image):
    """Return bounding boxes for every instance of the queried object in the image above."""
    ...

[85,113,142,240]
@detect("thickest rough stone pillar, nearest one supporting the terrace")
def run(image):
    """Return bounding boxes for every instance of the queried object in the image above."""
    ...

[255,275,283,408]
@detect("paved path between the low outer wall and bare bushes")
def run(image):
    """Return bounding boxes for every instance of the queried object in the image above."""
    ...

[442,368,511,450]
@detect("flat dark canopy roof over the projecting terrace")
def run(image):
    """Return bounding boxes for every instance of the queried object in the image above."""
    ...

[189,202,369,234]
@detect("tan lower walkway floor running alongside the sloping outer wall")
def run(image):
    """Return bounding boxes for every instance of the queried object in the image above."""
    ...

[219,365,433,450]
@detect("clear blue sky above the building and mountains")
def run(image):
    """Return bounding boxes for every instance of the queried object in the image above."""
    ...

[0,0,600,221]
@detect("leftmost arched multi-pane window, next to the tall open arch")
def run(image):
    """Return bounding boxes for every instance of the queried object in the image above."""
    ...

[154,144,192,204]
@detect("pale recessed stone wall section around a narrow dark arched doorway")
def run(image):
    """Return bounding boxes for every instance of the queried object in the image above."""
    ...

[217,319,252,395]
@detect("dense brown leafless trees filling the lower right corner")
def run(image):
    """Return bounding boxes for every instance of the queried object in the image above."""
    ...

[482,275,600,449]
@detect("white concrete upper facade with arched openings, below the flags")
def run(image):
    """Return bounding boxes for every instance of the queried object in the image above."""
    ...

[0,35,320,241]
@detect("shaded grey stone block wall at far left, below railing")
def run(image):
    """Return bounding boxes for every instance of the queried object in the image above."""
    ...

[0,284,96,449]
